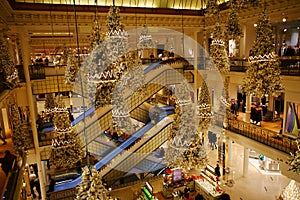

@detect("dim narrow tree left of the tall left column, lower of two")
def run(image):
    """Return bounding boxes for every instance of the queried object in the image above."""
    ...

[10,104,32,156]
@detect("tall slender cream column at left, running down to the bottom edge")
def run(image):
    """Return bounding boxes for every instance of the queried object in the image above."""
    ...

[19,31,46,200]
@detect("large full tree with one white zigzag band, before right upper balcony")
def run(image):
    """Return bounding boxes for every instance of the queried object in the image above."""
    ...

[243,9,283,98]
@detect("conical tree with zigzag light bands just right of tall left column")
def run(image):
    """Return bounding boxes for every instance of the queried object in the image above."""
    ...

[50,96,84,168]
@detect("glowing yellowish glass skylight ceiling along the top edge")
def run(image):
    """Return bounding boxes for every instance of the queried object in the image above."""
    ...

[14,0,229,10]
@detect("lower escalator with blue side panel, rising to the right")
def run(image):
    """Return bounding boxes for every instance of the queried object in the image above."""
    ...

[55,106,174,192]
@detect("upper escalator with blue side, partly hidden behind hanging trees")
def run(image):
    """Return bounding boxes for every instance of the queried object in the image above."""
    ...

[73,61,186,158]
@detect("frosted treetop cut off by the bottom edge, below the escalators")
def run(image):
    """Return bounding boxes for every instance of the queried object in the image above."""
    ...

[75,166,109,200]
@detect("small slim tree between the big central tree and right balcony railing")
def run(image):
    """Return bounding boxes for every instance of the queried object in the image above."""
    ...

[198,80,212,132]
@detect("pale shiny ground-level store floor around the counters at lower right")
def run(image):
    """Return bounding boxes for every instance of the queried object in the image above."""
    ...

[112,143,300,200]
